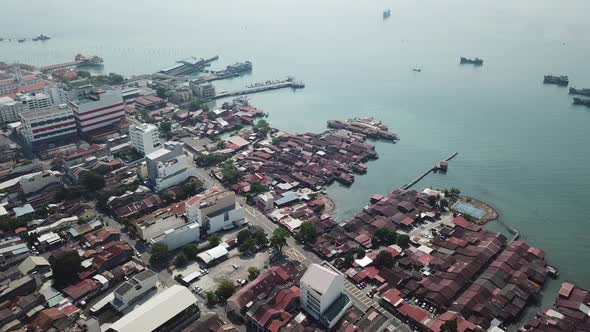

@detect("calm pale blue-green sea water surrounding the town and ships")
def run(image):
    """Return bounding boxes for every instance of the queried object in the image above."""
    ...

[0,0,590,303]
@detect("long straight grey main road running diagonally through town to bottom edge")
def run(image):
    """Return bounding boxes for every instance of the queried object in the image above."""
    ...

[192,168,412,332]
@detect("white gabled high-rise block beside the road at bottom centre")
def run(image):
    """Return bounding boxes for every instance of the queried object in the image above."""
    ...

[299,264,351,328]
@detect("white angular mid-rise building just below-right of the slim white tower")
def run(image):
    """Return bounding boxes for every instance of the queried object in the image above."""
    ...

[145,145,196,191]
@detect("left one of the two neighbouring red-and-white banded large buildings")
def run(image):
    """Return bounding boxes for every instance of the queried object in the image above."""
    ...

[20,105,77,150]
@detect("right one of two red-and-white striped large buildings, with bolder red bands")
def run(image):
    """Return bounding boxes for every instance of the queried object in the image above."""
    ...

[69,91,125,133]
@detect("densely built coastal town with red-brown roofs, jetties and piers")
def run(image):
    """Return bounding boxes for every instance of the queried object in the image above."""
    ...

[0,55,590,332]
